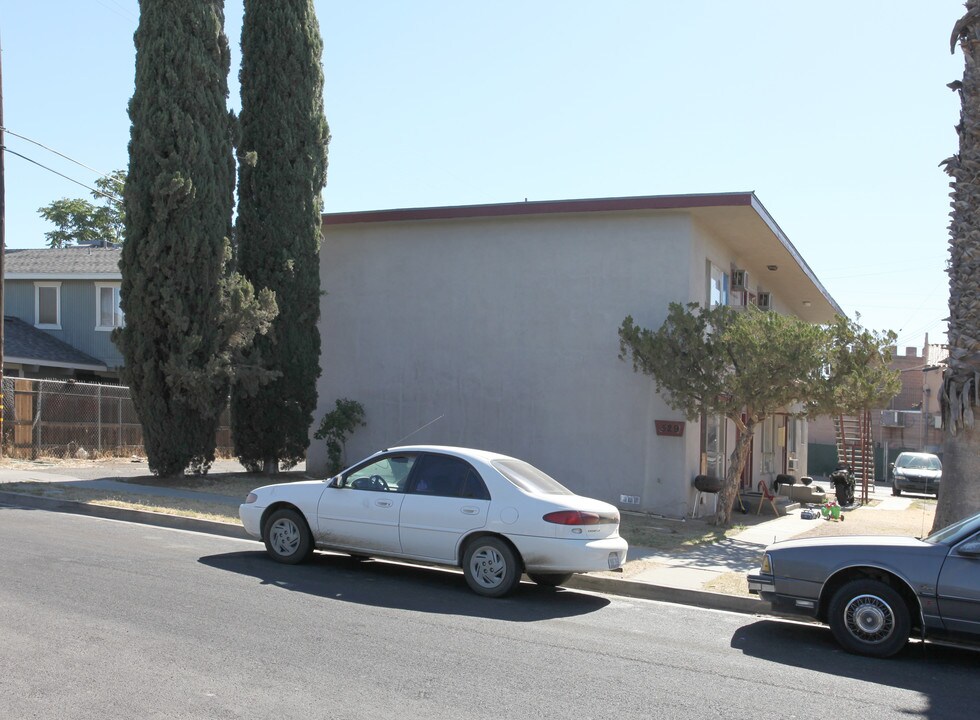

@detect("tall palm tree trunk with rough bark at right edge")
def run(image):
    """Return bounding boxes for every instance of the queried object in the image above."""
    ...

[933,0,980,529]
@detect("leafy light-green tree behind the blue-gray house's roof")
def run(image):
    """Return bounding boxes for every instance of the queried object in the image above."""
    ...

[38,170,126,248]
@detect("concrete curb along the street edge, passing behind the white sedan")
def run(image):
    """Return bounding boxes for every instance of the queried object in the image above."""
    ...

[0,492,774,615]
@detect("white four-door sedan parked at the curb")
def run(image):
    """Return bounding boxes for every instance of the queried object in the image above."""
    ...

[239,445,627,597]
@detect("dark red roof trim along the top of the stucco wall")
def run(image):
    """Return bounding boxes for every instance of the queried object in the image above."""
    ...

[323,192,754,225]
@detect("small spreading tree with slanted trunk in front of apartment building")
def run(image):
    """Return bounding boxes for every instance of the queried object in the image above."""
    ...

[619,303,897,525]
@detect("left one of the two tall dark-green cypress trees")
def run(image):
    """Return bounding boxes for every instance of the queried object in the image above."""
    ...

[121,0,275,475]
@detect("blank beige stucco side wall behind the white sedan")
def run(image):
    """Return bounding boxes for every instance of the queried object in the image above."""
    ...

[308,213,704,516]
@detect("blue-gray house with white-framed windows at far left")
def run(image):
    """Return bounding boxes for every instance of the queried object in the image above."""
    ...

[3,247,123,382]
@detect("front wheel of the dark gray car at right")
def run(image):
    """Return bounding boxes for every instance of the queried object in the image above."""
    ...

[828,579,911,657]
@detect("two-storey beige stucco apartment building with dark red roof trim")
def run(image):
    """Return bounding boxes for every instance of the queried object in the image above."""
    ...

[307,192,843,517]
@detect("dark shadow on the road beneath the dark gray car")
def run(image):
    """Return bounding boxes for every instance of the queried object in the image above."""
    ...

[731,620,980,720]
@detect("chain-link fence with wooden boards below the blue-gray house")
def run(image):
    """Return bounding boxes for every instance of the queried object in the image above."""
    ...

[3,377,232,460]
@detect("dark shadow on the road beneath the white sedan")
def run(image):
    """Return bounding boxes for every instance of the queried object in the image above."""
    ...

[200,552,610,622]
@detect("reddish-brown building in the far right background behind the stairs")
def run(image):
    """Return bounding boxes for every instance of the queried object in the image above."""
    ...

[809,335,949,480]
